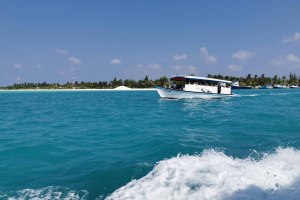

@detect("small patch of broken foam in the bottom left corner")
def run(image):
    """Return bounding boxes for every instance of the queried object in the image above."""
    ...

[0,186,88,200]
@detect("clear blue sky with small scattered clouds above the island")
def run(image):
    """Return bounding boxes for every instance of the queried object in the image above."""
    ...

[0,0,300,86]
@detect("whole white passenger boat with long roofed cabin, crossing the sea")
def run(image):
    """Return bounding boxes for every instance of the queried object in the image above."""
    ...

[156,76,232,99]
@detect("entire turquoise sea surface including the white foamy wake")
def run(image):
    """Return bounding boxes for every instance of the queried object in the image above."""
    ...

[0,89,300,200]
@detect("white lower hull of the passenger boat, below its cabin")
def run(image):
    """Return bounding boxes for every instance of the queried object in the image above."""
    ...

[156,87,232,99]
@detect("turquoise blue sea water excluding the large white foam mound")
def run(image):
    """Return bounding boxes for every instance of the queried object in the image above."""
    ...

[0,89,300,199]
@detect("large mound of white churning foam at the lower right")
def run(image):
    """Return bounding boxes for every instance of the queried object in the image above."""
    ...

[106,148,300,200]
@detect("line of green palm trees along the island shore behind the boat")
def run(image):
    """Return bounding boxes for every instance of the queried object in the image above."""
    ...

[1,73,300,90]
